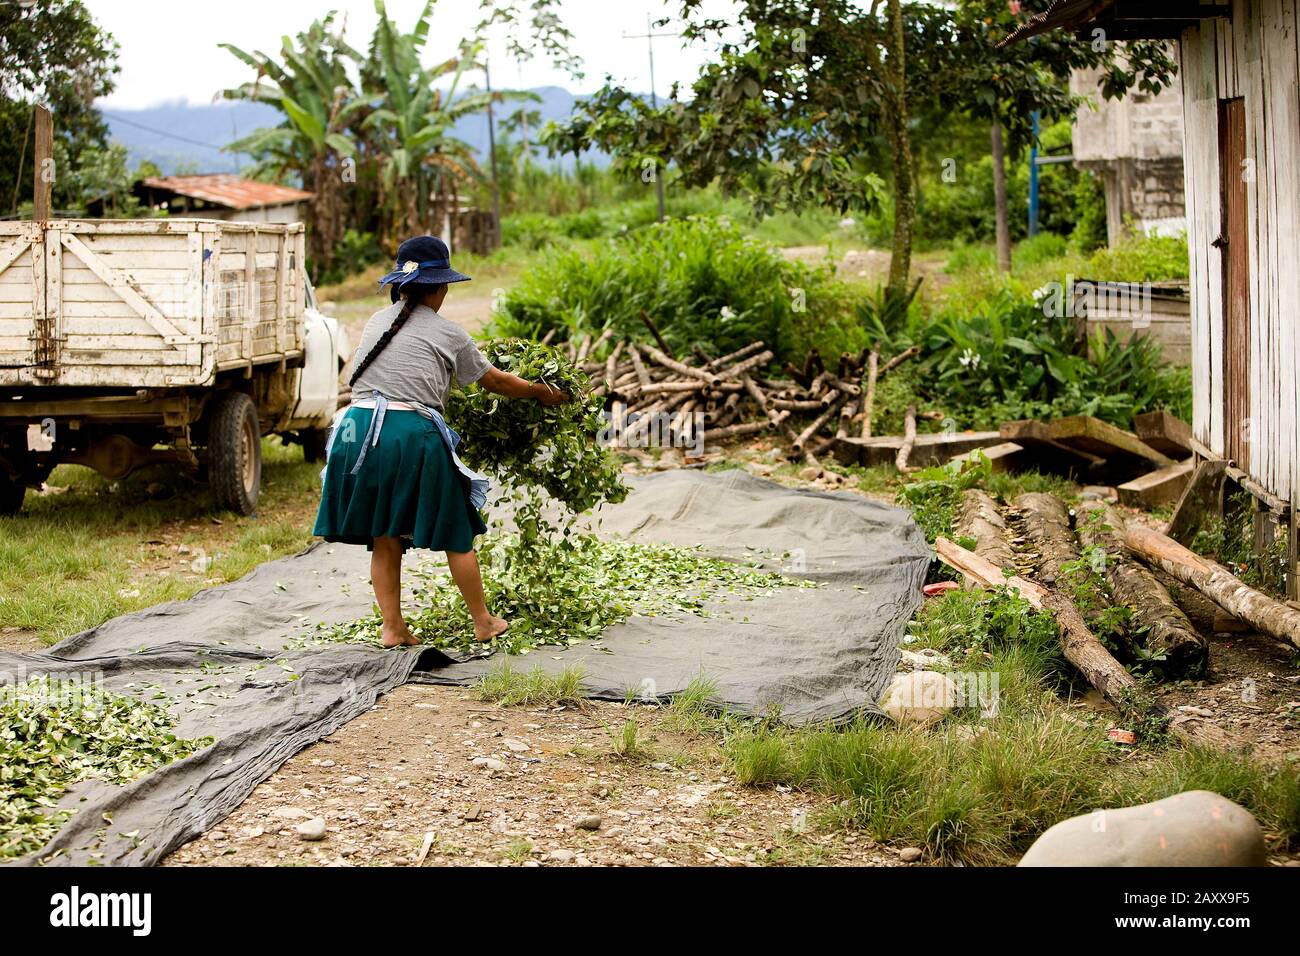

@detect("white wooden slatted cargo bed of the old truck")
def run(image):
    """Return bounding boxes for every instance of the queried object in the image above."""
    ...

[0,219,304,388]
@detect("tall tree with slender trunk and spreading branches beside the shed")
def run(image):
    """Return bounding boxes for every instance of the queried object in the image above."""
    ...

[545,0,1173,295]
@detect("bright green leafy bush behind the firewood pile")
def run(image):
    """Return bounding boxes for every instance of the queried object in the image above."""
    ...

[490,219,863,359]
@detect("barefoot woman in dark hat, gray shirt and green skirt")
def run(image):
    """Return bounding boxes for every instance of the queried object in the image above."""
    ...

[313,235,568,648]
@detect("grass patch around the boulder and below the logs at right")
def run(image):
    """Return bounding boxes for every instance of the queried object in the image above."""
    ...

[723,592,1300,865]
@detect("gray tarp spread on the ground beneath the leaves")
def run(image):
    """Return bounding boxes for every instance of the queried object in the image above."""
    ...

[0,471,930,864]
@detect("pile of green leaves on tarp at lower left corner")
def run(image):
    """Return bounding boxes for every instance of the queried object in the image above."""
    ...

[0,678,213,860]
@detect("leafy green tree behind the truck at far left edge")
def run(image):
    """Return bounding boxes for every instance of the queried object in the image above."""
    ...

[0,0,118,212]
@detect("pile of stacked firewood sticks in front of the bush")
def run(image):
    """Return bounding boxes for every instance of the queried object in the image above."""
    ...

[543,317,919,467]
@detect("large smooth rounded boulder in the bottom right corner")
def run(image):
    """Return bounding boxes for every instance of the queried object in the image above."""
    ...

[1021,790,1265,866]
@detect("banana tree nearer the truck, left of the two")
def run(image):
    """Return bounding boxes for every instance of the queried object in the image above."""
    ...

[220,12,369,274]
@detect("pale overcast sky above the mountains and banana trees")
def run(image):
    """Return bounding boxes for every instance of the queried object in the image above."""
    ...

[86,0,731,109]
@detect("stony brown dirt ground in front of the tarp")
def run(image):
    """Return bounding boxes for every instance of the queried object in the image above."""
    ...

[164,684,904,866]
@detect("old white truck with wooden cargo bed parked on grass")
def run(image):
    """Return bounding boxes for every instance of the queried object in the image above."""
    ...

[0,219,348,514]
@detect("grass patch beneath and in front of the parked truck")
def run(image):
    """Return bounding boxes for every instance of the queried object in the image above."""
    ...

[0,438,320,644]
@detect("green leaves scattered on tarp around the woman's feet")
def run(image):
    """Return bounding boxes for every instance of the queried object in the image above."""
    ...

[307,533,815,654]
